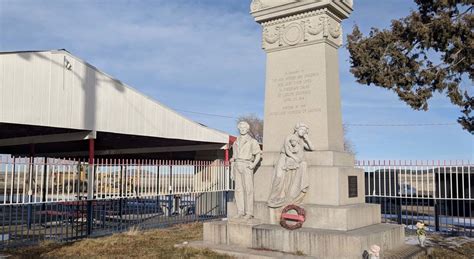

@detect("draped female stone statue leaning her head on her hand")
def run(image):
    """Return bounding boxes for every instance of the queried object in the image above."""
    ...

[267,123,314,208]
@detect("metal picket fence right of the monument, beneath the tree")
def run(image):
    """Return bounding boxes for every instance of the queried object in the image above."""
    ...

[358,161,474,237]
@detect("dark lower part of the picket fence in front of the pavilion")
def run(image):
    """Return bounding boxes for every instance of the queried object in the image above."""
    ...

[0,191,228,248]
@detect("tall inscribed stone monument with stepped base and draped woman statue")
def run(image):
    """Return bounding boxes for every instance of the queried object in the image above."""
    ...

[192,0,404,258]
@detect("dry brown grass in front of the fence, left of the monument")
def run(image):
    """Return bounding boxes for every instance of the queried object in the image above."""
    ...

[6,223,229,258]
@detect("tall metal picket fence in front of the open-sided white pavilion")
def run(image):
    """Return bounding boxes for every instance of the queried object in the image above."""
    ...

[0,159,231,249]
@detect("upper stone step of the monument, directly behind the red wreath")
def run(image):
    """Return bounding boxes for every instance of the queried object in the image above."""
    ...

[227,202,381,230]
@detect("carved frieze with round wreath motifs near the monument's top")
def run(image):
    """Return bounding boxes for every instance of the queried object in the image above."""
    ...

[262,8,342,51]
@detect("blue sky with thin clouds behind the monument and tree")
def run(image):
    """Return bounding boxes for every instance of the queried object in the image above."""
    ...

[0,0,474,160]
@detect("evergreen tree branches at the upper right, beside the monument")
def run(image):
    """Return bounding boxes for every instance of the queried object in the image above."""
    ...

[348,0,474,134]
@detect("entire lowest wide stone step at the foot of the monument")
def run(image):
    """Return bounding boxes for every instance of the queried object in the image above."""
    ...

[196,221,405,258]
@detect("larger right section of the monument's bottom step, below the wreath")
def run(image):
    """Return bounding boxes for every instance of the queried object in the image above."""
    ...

[252,224,404,258]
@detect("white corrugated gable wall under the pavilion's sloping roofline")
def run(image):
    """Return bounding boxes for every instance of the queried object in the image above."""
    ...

[0,51,228,143]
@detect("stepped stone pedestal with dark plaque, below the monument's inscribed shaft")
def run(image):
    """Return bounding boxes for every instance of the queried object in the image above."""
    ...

[214,160,405,258]
